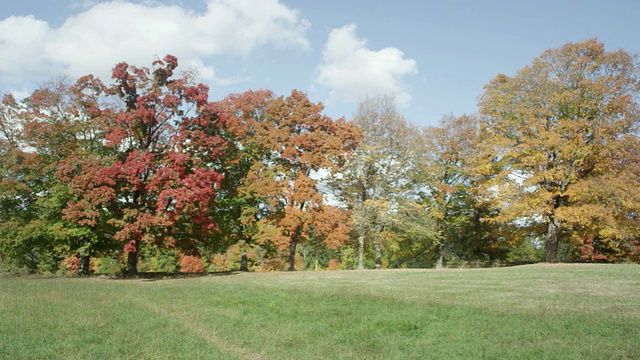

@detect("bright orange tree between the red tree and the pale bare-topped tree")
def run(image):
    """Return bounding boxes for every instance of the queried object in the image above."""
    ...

[240,90,358,271]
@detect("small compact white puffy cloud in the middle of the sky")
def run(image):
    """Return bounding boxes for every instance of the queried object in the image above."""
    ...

[314,24,418,106]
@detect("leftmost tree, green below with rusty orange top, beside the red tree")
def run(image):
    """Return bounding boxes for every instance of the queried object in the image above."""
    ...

[2,78,112,274]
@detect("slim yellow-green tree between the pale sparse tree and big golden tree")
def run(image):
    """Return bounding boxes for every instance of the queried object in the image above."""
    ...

[415,115,483,268]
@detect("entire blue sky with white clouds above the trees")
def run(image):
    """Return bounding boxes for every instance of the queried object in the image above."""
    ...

[0,0,640,126]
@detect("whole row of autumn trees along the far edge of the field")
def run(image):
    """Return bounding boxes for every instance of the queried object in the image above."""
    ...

[0,39,640,274]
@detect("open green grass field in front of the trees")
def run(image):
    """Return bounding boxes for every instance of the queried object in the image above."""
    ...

[0,265,640,359]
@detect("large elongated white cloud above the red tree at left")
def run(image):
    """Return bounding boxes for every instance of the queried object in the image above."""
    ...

[0,0,310,81]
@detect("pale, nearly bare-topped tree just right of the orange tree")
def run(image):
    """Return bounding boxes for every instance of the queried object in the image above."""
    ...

[331,96,419,269]
